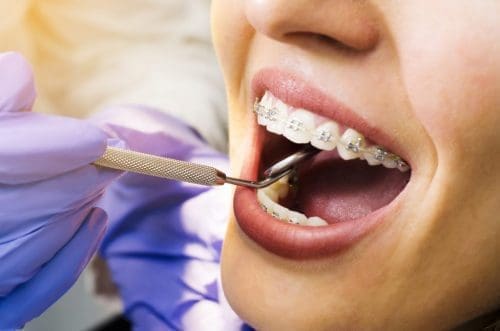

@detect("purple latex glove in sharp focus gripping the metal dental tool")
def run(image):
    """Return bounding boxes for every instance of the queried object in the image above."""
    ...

[0,53,119,330]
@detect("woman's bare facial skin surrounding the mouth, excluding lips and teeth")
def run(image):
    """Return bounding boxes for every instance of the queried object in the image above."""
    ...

[212,0,500,330]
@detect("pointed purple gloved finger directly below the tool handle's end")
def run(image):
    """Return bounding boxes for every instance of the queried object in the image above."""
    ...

[0,166,121,243]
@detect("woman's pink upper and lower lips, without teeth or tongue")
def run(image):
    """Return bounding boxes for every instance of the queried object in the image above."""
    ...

[234,69,404,259]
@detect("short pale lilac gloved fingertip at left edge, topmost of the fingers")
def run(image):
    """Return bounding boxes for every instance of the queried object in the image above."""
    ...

[0,52,36,113]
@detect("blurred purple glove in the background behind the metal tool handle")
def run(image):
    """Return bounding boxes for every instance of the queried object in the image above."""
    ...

[94,108,250,331]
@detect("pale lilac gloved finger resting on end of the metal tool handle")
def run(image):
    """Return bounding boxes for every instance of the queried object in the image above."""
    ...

[0,113,108,184]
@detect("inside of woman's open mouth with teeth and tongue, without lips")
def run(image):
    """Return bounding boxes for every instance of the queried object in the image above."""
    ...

[254,91,410,226]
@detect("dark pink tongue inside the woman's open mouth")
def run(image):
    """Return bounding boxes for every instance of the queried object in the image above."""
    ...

[292,153,410,223]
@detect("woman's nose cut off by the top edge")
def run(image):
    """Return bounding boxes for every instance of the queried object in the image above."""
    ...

[245,0,379,51]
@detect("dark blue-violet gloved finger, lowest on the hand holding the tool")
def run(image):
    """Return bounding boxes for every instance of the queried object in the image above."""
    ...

[0,208,107,329]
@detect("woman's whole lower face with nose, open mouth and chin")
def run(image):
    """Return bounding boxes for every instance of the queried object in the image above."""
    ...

[212,0,500,330]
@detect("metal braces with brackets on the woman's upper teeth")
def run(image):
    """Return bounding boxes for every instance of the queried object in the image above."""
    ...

[253,100,410,172]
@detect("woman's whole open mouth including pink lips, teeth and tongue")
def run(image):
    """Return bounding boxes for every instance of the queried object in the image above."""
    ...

[234,70,411,259]
